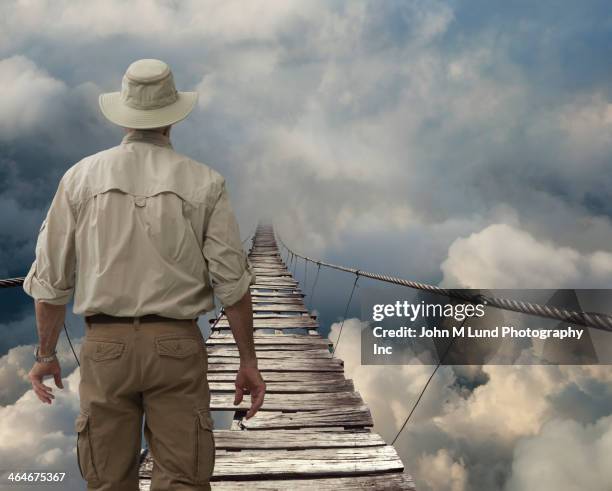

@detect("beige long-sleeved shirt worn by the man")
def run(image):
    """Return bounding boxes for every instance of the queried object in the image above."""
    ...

[23,131,255,319]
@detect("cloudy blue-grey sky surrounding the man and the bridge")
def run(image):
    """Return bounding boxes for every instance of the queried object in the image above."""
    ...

[0,0,612,491]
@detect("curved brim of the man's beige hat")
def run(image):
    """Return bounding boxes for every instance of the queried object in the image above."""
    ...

[98,92,198,130]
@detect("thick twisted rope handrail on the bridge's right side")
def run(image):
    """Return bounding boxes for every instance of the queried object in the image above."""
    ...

[277,234,612,332]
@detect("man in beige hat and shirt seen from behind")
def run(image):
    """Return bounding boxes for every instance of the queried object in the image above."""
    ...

[24,60,265,491]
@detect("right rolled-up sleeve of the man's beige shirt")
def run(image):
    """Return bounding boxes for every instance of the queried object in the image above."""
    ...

[203,182,255,307]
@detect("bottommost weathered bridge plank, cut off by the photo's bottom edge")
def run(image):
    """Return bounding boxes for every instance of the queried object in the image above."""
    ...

[140,472,416,491]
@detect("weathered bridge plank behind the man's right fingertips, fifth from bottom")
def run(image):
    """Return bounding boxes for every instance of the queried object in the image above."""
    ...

[210,392,363,411]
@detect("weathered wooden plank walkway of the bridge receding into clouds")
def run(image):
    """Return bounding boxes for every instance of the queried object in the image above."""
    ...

[140,225,415,491]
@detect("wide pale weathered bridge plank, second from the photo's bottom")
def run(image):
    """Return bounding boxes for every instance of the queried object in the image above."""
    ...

[139,445,404,481]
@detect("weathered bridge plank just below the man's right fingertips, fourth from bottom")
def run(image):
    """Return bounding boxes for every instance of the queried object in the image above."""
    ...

[242,405,373,430]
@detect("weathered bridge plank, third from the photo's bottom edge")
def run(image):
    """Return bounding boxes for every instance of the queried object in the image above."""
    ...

[209,429,386,450]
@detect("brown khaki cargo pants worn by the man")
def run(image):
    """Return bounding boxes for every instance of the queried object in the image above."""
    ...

[75,319,215,491]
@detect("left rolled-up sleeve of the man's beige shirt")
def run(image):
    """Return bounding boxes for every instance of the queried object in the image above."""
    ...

[23,179,76,305]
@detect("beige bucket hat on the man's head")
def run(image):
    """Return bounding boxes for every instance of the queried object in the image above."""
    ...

[98,59,198,129]
